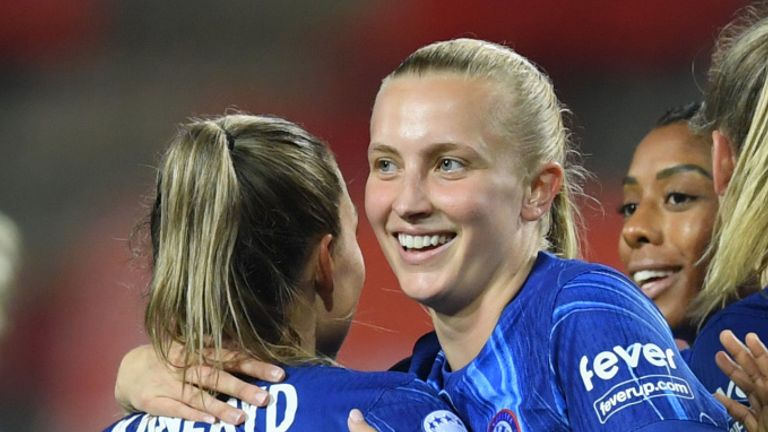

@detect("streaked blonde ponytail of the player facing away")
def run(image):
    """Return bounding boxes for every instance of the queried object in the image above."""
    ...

[145,121,240,363]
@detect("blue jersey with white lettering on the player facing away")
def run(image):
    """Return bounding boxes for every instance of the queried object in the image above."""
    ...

[105,366,466,432]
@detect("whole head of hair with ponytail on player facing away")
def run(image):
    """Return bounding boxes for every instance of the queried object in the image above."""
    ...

[145,114,343,373]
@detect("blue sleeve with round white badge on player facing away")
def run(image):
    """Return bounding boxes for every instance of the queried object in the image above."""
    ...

[364,380,467,432]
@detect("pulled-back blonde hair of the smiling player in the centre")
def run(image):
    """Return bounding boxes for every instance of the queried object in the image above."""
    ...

[382,39,586,258]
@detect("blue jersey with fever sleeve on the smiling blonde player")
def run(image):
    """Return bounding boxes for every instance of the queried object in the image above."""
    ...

[420,253,729,432]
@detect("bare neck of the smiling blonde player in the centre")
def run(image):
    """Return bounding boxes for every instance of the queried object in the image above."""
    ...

[429,253,536,371]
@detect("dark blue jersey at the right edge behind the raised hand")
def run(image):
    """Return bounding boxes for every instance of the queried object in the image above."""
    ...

[686,288,768,431]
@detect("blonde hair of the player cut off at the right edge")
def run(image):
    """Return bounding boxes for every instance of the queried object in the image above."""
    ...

[691,7,768,324]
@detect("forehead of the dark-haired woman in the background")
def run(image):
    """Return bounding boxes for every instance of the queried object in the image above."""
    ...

[630,123,712,174]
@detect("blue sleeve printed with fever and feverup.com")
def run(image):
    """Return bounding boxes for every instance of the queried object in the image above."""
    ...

[550,270,728,431]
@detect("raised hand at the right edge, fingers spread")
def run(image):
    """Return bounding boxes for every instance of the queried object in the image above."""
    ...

[715,330,768,432]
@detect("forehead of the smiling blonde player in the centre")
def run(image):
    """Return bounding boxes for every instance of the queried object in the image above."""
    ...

[371,73,494,147]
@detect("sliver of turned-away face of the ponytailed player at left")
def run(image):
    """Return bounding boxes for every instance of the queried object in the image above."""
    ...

[316,184,365,357]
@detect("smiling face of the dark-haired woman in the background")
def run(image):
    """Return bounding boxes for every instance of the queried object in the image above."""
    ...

[619,122,717,328]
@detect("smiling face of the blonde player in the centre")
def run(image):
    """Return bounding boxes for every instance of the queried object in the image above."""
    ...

[365,73,524,313]
